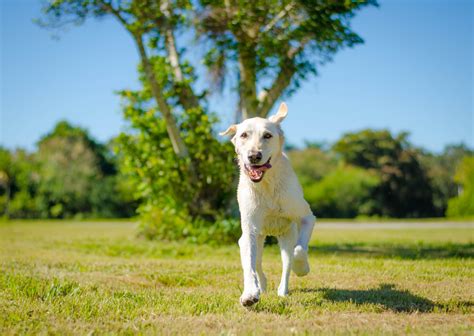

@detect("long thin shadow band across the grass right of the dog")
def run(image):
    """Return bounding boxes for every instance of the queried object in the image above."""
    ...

[310,243,474,260]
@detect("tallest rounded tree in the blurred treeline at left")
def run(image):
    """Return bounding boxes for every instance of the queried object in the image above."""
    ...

[36,121,133,218]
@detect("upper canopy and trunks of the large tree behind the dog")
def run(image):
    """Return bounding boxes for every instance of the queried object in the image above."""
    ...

[40,0,376,159]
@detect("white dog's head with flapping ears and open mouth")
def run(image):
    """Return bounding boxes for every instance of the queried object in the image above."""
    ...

[220,103,288,182]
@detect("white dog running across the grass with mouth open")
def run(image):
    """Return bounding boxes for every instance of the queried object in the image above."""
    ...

[220,103,316,306]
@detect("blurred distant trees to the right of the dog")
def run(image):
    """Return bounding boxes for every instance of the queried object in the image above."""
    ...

[289,133,474,218]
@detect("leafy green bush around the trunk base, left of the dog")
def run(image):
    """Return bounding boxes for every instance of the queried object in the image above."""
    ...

[118,88,239,242]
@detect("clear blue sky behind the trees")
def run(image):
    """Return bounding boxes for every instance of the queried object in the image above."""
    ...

[0,0,474,151]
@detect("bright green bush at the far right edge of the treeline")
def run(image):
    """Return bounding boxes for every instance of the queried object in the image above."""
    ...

[447,156,474,217]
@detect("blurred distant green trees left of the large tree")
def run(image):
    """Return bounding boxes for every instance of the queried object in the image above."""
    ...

[0,121,135,218]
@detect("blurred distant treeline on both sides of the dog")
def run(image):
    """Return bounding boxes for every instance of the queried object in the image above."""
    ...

[0,122,474,218]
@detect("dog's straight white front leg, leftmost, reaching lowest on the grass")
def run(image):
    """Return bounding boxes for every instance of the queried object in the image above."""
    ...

[239,219,260,306]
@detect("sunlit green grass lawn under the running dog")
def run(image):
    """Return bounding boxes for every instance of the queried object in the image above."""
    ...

[0,221,474,335]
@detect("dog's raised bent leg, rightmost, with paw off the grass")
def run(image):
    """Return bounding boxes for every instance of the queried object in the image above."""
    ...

[293,215,316,276]
